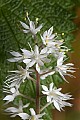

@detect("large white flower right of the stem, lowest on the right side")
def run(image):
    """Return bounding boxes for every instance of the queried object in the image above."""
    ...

[42,83,72,111]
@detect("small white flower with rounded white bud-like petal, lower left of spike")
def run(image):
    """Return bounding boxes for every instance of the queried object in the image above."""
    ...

[3,83,20,104]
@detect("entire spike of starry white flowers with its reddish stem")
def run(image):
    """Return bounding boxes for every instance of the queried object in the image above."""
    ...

[3,15,75,120]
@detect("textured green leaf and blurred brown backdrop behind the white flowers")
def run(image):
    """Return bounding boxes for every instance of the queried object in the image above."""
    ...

[0,0,80,120]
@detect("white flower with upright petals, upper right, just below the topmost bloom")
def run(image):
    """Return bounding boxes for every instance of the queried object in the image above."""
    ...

[41,26,55,46]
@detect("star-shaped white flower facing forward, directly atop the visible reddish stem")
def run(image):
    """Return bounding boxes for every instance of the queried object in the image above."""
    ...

[23,45,50,73]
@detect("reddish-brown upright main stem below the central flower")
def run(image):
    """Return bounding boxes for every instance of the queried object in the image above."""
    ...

[36,71,40,114]
